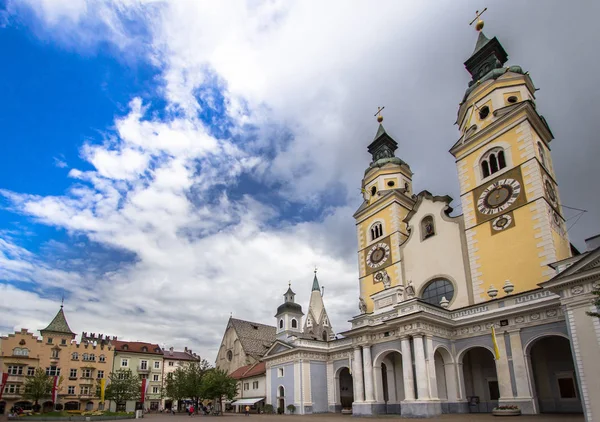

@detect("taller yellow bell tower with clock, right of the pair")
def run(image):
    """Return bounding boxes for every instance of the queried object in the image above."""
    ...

[450,21,570,302]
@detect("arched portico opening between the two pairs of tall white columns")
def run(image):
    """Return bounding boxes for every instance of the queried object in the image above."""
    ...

[373,350,404,415]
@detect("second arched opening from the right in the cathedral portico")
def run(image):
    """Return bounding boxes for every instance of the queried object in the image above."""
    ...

[462,346,500,413]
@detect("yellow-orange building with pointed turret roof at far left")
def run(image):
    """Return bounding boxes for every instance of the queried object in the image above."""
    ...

[0,306,114,414]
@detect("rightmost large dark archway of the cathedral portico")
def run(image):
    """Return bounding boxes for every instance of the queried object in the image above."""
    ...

[527,335,583,413]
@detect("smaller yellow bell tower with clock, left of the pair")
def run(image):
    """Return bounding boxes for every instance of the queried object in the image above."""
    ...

[354,112,415,312]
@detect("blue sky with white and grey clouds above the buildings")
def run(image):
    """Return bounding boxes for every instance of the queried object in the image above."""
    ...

[0,0,600,360]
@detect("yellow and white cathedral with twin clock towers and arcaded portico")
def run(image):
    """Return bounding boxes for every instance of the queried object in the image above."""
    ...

[217,21,600,421]
